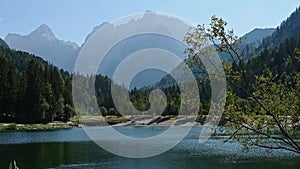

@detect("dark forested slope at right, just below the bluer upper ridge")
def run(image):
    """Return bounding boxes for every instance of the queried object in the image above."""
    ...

[232,35,300,98]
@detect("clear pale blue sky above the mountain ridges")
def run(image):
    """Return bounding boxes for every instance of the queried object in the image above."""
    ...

[0,0,300,45]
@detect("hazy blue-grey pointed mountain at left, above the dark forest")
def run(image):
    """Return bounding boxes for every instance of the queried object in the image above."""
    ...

[5,24,79,71]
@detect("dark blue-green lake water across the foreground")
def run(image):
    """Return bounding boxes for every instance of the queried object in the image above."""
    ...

[0,127,300,169]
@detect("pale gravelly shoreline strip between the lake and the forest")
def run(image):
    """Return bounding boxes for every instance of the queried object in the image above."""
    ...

[0,116,222,132]
